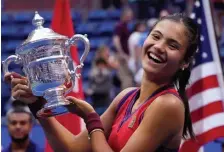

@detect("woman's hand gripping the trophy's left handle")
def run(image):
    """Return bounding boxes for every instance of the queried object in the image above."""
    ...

[4,72,38,104]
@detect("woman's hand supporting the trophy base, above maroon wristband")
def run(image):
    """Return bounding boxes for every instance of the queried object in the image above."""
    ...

[66,96,95,119]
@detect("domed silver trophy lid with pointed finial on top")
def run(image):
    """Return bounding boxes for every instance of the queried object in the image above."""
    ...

[22,11,68,45]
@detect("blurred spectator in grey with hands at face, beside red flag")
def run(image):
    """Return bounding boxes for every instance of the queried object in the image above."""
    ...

[87,58,112,115]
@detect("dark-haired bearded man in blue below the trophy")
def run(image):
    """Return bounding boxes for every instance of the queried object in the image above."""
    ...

[2,100,43,152]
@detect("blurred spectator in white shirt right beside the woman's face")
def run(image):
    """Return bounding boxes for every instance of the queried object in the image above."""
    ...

[128,22,146,75]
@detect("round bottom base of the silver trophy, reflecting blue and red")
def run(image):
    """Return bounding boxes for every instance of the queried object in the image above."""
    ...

[37,101,69,118]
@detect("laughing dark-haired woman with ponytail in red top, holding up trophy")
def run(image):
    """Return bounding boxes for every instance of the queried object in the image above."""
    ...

[5,14,199,152]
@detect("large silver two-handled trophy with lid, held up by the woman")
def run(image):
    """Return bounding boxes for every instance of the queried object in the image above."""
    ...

[3,12,90,117]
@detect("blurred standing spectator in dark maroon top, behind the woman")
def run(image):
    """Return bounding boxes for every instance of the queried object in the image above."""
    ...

[113,8,133,90]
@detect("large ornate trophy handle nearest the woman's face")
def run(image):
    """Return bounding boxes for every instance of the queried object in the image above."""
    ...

[65,34,90,81]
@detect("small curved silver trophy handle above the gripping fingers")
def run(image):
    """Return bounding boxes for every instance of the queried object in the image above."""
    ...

[2,55,21,74]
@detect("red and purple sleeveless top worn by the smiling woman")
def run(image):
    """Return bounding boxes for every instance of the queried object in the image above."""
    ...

[108,85,180,152]
